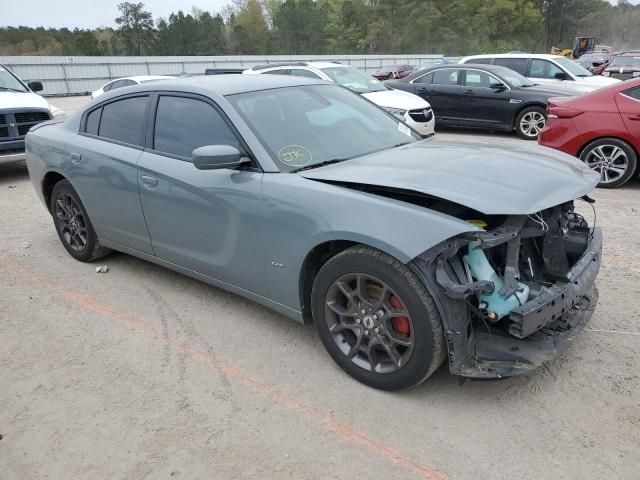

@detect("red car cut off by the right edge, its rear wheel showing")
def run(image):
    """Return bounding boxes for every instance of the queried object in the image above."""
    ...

[538,79,640,188]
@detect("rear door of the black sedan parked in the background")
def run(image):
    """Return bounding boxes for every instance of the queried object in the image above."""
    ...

[412,68,462,123]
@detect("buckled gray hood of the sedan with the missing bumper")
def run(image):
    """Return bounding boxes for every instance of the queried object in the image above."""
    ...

[299,137,600,215]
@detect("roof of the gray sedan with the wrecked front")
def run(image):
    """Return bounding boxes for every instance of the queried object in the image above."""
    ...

[123,74,329,95]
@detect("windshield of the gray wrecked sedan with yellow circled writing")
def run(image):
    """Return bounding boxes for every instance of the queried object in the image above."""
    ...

[226,85,420,172]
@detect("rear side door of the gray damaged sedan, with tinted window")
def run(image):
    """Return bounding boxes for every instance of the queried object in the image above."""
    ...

[65,94,153,254]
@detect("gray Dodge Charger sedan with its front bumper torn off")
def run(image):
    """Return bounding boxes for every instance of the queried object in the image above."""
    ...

[26,75,602,390]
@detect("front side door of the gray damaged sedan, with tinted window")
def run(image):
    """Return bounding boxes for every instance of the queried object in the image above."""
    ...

[138,93,266,295]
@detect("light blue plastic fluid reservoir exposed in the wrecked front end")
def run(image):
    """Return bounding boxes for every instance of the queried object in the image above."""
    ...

[464,241,529,320]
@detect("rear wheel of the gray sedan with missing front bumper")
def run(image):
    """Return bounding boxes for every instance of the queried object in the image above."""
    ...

[51,180,111,262]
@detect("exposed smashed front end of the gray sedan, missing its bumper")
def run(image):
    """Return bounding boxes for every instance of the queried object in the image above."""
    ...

[411,197,602,378]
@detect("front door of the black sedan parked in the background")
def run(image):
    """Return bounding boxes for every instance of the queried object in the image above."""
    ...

[460,68,511,126]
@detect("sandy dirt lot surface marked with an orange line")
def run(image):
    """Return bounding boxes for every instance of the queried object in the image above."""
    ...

[0,97,640,480]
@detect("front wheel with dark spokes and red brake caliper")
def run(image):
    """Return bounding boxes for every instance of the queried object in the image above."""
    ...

[311,245,445,390]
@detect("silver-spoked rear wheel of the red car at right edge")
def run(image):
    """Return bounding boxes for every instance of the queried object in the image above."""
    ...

[580,138,638,188]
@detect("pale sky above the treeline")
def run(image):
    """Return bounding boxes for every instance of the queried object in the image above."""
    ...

[0,0,640,28]
